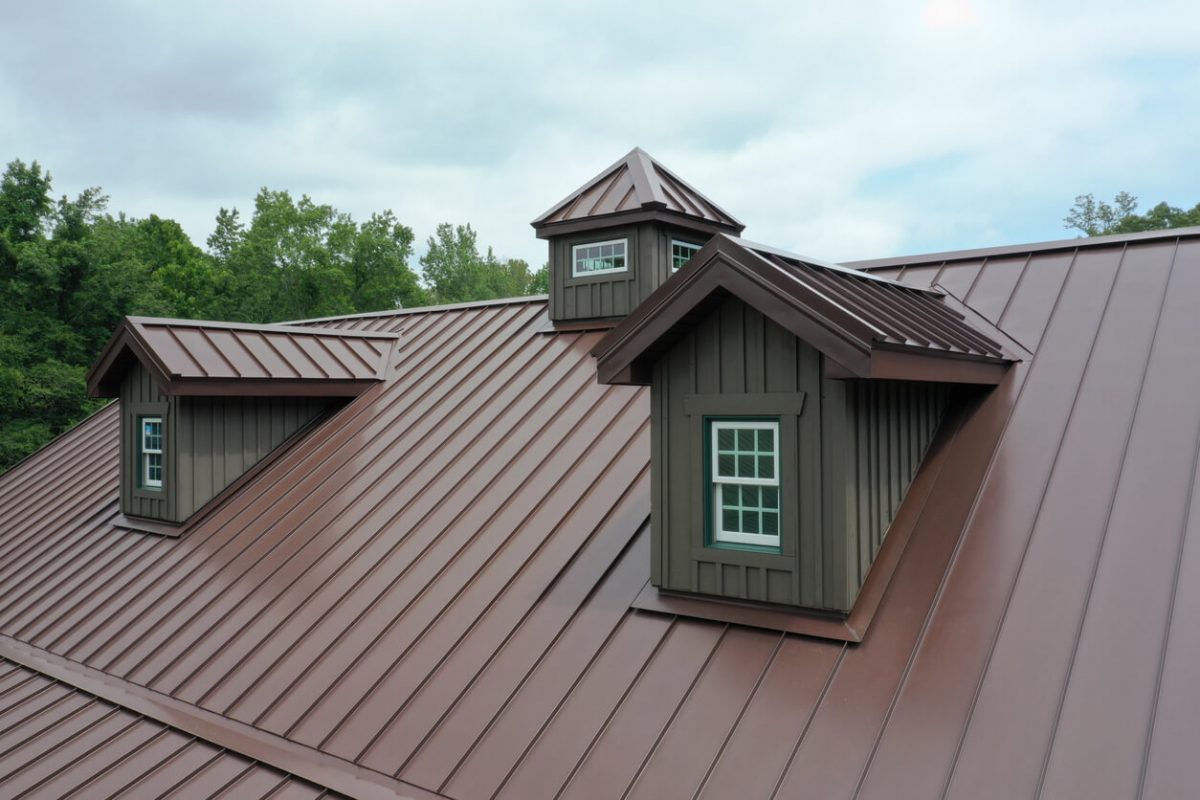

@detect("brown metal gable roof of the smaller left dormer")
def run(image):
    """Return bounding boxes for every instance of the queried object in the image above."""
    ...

[86,317,400,397]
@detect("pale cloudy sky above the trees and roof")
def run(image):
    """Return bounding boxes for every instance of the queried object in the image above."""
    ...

[0,0,1200,265]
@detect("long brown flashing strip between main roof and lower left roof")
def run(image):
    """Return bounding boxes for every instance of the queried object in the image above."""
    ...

[0,634,443,800]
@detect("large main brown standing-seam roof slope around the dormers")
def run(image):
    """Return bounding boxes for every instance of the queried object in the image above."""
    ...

[0,226,1200,800]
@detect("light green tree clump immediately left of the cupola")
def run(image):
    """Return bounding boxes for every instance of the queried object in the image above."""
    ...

[421,222,539,303]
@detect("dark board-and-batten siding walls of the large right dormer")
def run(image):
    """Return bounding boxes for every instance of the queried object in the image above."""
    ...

[650,297,947,612]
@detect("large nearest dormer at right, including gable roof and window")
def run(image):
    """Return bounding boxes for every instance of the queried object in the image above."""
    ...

[595,235,1014,640]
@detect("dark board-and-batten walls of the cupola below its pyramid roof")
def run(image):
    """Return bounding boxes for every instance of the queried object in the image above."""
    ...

[550,222,709,321]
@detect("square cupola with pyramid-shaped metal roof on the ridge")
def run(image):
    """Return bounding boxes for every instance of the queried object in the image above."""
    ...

[532,148,743,323]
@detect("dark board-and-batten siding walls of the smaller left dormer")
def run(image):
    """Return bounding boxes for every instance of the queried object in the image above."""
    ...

[121,363,332,522]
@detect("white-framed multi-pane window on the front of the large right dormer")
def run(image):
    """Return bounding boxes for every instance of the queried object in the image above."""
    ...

[708,419,780,547]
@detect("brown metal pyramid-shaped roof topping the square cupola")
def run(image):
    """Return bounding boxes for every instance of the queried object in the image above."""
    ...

[530,148,745,239]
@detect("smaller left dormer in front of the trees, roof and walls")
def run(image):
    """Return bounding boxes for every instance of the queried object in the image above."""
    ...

[88,317,397,535]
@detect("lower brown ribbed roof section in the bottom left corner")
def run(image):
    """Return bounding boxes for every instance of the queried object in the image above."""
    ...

[0,658,342,800]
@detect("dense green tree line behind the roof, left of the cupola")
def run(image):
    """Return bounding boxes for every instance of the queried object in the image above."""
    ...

[0,160,547,473]
